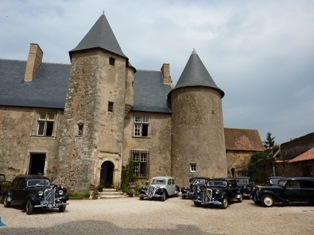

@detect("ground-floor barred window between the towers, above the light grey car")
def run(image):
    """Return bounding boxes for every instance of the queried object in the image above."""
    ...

[131,150,148,178]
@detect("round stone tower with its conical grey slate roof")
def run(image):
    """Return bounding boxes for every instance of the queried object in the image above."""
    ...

[168,50,227,186]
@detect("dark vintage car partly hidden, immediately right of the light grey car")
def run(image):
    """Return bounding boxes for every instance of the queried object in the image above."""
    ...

[181,177,209,199]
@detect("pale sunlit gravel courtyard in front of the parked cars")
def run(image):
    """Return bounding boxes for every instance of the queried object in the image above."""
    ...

[0,197,314,235]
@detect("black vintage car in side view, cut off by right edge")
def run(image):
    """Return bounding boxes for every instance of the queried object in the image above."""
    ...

[252,177,314,207]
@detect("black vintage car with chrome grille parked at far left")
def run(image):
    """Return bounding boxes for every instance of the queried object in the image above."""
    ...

[3,175,69,215]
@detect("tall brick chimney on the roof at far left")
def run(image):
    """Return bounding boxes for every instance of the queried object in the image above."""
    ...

[24,43,44,82]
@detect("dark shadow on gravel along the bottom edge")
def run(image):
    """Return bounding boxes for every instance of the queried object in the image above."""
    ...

[0,220,223,235]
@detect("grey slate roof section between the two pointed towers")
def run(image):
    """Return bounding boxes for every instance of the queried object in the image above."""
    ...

[132,70,171,113]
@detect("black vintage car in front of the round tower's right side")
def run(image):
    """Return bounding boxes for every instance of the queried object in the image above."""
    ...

[194,178,243,209]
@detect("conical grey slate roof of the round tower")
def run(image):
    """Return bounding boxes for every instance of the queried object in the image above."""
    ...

[174,49,225,98]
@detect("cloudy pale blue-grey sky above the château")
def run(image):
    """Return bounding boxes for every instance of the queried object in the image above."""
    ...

[0,0,314,144]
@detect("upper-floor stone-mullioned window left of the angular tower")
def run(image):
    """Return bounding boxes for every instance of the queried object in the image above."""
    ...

[37,112,55,136]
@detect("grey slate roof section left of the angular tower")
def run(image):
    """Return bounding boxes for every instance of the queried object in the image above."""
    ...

[0,59,70,109]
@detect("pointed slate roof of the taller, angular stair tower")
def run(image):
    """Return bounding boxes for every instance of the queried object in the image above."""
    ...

[69,15,127,58]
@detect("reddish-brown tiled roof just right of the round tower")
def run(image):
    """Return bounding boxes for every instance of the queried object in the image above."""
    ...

[224,128,265,151]
